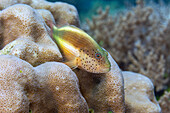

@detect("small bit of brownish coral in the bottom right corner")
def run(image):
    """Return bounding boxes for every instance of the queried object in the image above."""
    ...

[159,91,170,113]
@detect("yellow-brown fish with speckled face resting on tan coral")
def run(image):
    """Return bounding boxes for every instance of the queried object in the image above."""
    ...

[51,25,111,73]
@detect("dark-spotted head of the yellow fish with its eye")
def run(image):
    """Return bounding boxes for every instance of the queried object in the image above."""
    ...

[79,48,111,73]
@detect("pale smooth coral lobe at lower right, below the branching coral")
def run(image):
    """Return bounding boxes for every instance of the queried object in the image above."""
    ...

[122,71,161,113]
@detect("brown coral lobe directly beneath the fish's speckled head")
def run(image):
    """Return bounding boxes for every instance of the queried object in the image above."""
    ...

[75,54,125,113]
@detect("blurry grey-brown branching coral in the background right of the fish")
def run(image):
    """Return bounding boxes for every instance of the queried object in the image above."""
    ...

[87,0,170,91]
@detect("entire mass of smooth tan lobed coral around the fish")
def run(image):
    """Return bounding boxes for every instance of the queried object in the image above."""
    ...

[0,0,164,113]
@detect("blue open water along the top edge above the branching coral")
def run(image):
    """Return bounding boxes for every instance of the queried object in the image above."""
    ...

[47,0,170,22]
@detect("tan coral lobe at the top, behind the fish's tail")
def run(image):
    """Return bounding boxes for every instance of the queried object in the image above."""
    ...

[28,0,80,26]
